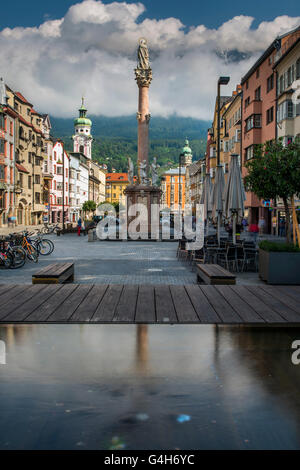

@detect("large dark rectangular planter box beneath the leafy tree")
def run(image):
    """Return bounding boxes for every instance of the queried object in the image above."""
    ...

[258,249,300,285]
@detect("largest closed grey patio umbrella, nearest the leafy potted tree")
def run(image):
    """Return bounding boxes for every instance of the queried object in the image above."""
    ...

[224,154,246,243]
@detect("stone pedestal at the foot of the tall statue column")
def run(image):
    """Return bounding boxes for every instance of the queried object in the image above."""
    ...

[124,184,161,240]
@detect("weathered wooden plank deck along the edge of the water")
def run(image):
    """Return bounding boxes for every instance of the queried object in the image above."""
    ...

[0,284,300,326]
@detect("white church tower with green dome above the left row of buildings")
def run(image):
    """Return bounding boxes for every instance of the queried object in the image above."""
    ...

[73,98,93,160]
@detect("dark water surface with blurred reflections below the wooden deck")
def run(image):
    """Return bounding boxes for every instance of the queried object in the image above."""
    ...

[0,325,300,449]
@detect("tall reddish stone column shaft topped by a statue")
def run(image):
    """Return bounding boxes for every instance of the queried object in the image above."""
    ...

[135,38,152,183]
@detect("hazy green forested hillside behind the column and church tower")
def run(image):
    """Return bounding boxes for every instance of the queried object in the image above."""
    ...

[51,116,209,171]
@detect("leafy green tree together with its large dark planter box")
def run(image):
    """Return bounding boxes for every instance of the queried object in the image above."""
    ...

[245,139,300,284]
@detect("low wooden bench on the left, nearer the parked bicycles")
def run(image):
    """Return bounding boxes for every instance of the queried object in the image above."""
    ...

[32,263,74,284]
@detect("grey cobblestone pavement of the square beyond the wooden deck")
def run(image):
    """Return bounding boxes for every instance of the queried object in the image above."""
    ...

[0,234,260,285]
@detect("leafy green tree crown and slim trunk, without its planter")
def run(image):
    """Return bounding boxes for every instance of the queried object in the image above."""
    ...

[245,139,300,242]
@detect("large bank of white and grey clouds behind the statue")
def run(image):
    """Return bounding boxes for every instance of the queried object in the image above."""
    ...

[0,0,300,119]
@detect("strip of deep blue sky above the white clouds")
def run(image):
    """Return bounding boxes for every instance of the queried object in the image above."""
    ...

[0,0,300,29]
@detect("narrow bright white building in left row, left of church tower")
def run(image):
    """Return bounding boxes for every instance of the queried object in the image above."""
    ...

[49,142,70,223]
